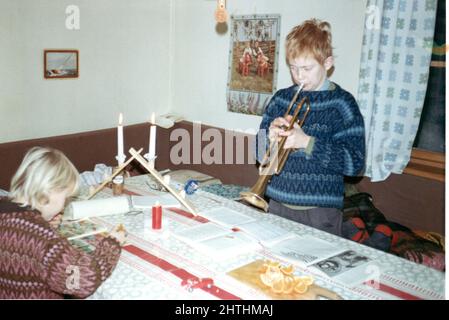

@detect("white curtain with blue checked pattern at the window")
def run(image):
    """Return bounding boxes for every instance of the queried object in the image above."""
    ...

[358,0,437,181]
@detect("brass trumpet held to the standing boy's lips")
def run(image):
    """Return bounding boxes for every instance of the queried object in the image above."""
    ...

[240,84,310,212]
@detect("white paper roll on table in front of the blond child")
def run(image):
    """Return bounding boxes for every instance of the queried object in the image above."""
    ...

[64,196,130,220]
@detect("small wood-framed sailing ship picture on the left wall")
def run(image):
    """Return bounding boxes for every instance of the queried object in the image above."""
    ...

[44,49,79,79]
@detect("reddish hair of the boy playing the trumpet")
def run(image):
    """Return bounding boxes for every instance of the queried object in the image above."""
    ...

[285,19,332,65]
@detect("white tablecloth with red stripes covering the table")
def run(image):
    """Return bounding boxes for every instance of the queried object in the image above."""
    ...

[89,175,445,300]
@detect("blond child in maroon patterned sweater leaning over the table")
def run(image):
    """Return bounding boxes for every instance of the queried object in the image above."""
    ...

[0,147,125,299]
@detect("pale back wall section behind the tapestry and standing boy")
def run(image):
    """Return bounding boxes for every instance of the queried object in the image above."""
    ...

[170,0,366,131]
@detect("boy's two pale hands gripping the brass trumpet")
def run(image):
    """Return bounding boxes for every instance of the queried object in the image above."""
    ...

[269,115,310,149]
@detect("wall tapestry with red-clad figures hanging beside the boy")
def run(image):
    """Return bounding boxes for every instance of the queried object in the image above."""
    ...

[227,15,281,115]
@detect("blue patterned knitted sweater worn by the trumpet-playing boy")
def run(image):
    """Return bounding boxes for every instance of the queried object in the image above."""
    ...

[256,84,365,208]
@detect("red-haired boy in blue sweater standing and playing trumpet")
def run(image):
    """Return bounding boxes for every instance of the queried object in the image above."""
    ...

[256,19,365,235]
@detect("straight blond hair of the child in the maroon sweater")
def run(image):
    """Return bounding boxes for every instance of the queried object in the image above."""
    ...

[9,147,79,209]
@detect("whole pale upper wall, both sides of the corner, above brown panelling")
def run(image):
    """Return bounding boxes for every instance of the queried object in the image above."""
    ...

[0,0,366,143]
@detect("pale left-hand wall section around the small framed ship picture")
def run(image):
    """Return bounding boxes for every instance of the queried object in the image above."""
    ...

[0,0,171,143]
